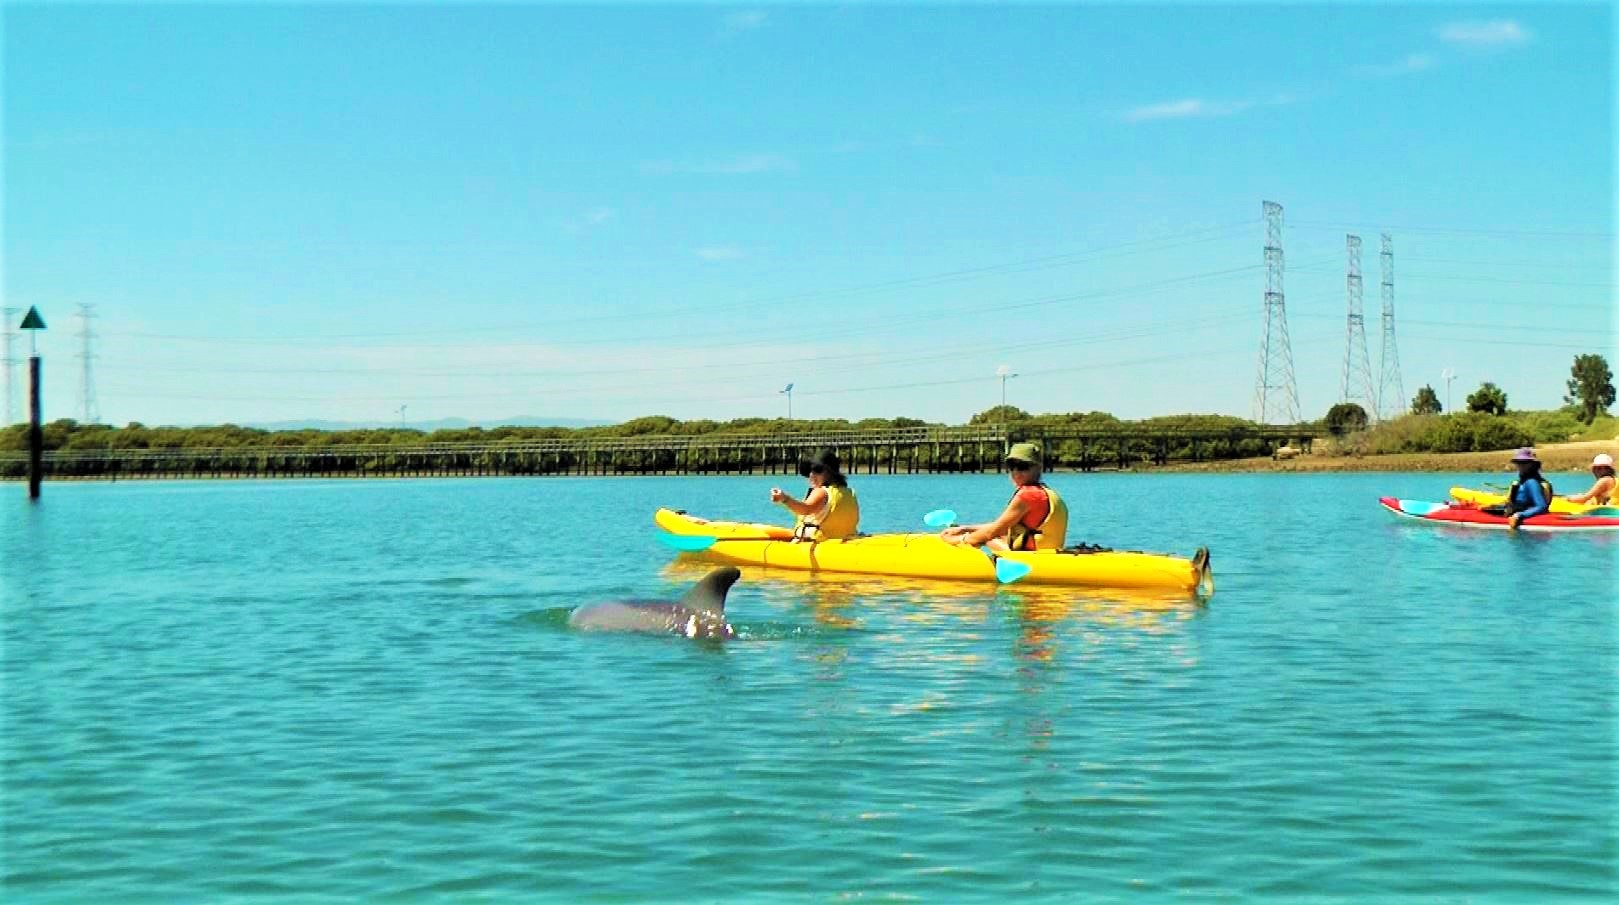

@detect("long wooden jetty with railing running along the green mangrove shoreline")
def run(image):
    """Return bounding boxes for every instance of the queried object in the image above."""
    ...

[0,426,1310,479]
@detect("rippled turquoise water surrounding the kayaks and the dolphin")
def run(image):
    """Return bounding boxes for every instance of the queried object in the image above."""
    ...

[0,474,1619,902]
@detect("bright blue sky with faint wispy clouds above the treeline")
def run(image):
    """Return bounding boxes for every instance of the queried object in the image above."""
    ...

[3,3,1619,424]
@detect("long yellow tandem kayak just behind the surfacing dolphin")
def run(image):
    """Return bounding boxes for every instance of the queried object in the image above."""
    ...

[652,508,1214,594]
